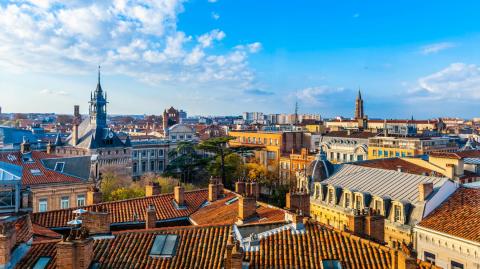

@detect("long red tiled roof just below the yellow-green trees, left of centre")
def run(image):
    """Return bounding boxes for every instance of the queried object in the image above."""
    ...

[32,189,208,227]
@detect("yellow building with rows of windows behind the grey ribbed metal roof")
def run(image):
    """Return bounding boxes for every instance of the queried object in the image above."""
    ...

[368,136,458,160]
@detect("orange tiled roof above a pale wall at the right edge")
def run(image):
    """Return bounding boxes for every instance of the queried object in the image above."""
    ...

[418,187,480,242]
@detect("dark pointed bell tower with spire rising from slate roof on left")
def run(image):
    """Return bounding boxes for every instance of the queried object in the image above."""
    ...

[89,66,108,128]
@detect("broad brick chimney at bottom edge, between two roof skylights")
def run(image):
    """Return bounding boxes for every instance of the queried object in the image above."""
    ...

[56,227,93,269]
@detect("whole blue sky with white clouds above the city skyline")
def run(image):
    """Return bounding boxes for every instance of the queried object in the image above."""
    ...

[0,0,480,119]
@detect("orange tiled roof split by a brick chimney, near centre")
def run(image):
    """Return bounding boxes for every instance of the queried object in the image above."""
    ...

[190,192,285,225]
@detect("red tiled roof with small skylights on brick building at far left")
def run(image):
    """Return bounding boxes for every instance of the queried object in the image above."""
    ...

[0,151,85,186]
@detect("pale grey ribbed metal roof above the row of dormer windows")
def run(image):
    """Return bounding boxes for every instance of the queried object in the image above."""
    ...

[322,164,448,204]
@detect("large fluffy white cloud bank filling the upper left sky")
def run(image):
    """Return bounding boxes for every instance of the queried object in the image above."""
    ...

[0,0,261,88]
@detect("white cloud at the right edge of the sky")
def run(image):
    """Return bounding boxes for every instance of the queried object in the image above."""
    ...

[412,63,480,100]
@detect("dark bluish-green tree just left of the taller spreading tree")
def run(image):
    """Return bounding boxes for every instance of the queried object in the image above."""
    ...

[165,141,209,182]
